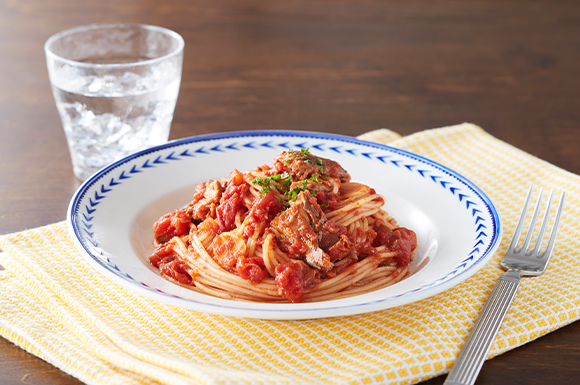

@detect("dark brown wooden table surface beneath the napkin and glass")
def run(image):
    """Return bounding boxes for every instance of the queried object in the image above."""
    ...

[0,0,580,385]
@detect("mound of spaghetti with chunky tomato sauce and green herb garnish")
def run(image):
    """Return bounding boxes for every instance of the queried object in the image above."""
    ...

[149,149,417,302]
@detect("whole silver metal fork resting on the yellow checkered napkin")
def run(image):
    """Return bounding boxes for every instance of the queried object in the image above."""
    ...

[444,187,565,385]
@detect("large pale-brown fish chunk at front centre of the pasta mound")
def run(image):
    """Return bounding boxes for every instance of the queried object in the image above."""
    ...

[270,191,333,272]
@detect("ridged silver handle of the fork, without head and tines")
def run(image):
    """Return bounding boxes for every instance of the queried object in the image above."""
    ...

[444,270,520,385]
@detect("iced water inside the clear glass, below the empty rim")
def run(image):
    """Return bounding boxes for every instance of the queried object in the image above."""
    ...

[52,62,180,180]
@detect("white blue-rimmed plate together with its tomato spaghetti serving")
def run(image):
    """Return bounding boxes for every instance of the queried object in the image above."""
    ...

[67,130,502,320]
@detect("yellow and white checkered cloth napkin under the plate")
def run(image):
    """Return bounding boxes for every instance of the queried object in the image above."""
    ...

[0,124,580,385]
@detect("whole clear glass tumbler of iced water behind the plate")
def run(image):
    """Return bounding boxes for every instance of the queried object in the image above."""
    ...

[44,24,184,180]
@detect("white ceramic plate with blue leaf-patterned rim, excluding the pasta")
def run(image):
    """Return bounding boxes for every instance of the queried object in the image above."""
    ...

[67,131,501,319]
